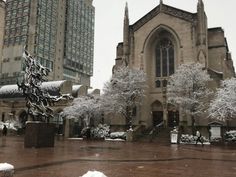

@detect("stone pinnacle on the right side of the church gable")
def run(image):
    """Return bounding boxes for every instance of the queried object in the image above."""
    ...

[196,0,208,67]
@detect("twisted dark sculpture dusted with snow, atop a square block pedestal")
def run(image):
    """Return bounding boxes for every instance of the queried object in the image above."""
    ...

[17,50,71,122]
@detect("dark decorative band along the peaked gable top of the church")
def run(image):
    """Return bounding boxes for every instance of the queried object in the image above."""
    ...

[131,4,196,31]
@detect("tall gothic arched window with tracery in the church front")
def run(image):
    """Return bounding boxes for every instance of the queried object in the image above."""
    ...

[156,38,175,87]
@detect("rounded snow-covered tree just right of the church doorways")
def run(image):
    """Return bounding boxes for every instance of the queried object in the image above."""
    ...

[167,63,212,129]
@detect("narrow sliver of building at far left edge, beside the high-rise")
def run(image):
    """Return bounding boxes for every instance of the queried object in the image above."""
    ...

[0,0,5,73]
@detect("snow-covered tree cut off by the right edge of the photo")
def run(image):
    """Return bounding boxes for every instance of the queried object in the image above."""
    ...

[209,78,236,121]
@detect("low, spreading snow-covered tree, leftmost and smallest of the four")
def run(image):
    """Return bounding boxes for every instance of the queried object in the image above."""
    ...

[63,95,102,128]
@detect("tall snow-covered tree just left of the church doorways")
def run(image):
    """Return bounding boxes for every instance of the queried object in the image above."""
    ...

[103,67,146,129]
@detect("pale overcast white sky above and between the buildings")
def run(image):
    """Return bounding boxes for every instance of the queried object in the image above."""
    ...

[91,0,236,89]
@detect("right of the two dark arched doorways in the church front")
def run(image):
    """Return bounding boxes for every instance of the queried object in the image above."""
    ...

[167,104,179,127]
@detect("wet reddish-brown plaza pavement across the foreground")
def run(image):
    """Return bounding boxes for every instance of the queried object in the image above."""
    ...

[0,137,236,177]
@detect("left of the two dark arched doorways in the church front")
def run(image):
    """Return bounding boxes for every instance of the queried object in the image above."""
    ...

[151,100,163,126]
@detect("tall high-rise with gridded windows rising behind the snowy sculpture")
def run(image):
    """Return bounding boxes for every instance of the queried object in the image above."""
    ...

[0,0,95,86]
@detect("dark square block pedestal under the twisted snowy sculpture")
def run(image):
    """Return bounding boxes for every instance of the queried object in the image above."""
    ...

[24,122,55,148]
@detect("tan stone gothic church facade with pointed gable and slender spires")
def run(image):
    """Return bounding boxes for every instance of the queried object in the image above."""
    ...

[111,0,235,130]
